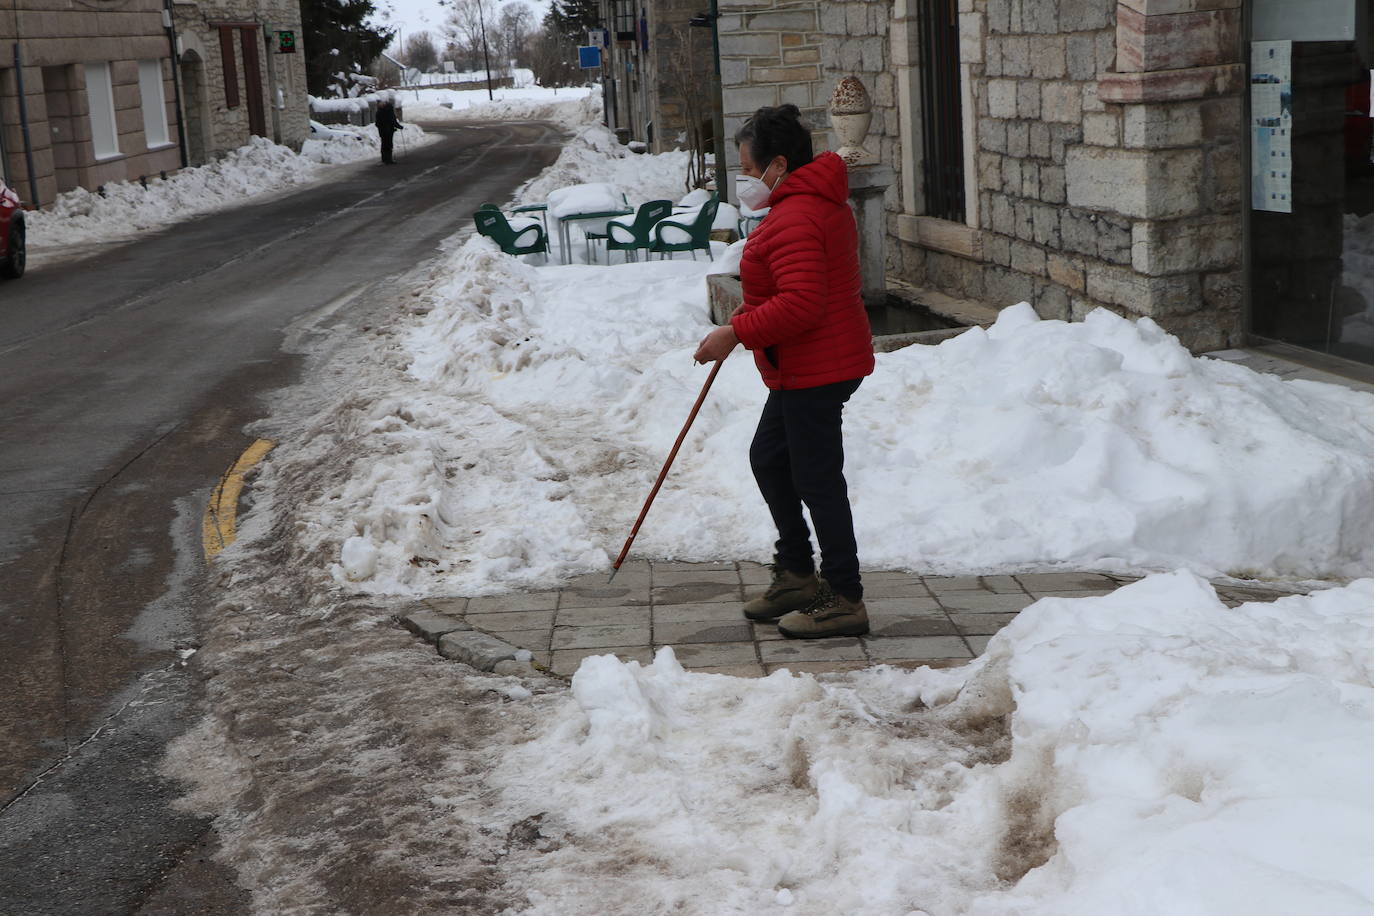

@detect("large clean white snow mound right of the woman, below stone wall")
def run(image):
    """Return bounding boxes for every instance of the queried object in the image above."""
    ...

[849,305,1374,578]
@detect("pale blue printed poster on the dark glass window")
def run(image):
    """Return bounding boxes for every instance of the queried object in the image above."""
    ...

[1250,41,1293,213]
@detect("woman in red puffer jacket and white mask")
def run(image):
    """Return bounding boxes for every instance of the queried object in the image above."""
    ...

[697,104,874,639]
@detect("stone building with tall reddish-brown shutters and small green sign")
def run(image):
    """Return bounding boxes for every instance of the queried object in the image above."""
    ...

[172,0,311,165]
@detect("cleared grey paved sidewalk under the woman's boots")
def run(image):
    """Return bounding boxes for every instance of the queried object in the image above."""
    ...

[408,560,1289,677]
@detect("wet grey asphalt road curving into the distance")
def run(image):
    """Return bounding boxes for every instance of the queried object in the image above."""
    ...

[0,124,559,913]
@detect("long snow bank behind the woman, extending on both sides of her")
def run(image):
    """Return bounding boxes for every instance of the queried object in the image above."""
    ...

[315,239,1374,593]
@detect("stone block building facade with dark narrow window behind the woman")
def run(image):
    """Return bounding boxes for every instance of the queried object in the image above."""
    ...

[720,0,1264,350]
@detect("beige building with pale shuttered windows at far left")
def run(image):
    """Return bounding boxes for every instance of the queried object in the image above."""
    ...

[0,0,181,206]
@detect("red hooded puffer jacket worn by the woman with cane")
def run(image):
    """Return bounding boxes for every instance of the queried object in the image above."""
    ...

[730,152,872,389]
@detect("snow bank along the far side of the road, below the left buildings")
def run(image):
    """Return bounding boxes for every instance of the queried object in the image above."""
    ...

[26,126,423,251]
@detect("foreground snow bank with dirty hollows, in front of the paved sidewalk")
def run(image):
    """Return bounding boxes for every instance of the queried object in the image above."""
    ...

[489,573,1374,916]
